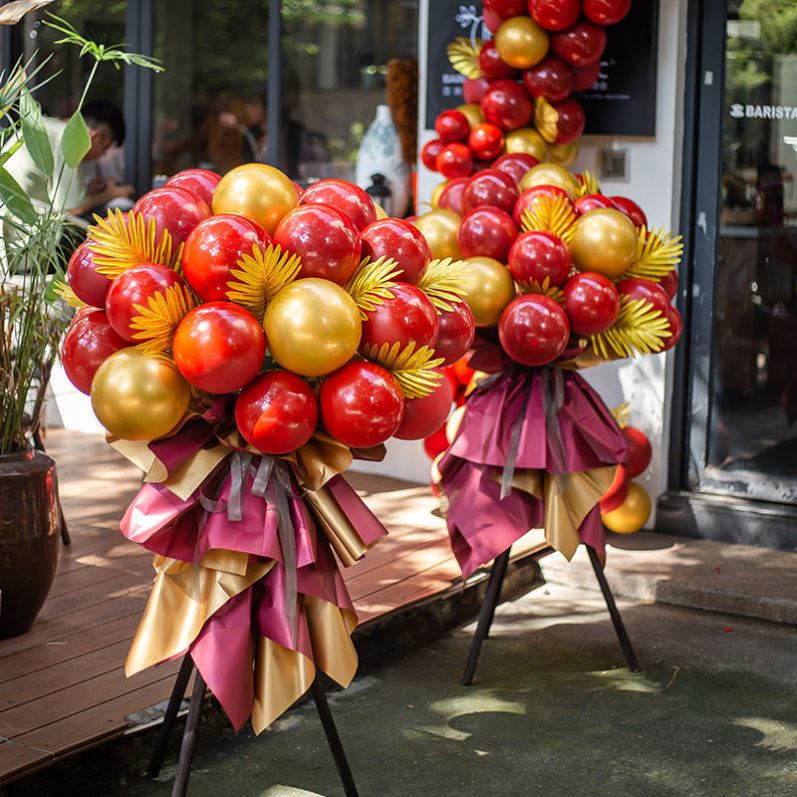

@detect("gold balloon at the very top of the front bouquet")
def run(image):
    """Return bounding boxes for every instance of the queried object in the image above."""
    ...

[213,163,299,235]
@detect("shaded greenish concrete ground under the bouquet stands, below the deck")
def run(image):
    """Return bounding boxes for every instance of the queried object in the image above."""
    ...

[8,585,797,797]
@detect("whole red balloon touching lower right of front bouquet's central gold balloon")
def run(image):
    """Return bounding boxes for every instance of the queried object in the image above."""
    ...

[319,361,404,448]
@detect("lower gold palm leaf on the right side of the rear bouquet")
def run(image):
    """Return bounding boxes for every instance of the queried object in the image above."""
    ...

[589,296,671,360]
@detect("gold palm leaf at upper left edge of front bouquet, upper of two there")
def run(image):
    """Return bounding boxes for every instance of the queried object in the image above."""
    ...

[89,209,183,279]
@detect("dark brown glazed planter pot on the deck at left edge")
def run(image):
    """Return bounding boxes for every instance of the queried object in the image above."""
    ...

[0,451,59,639]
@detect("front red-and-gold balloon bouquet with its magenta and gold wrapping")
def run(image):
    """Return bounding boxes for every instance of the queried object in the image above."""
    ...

[61,164,475,731]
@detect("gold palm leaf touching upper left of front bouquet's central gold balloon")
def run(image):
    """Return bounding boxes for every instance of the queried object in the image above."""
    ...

[227,244,302,321]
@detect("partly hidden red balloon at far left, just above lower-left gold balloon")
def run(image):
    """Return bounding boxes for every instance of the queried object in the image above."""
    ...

[61,310,130,395]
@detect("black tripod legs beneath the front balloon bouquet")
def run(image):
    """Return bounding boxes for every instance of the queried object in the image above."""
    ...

[147,653,358,797]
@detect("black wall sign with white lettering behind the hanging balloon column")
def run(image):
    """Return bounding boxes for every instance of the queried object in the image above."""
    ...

[426,0,659,136]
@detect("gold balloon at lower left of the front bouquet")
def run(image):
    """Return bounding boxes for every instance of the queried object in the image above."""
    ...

[91,347,191,440]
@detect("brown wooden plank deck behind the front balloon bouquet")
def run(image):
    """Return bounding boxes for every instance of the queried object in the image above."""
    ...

[0,431,540,785]
